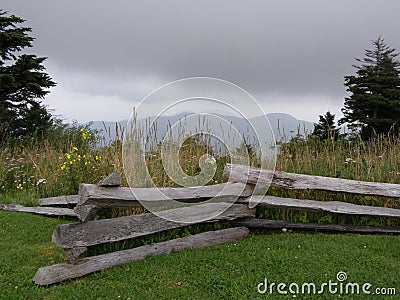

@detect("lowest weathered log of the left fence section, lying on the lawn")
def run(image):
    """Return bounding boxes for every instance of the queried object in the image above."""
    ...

[33,227,249,285]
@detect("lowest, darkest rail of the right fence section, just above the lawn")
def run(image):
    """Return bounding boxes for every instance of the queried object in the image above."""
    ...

[231,218,400,234]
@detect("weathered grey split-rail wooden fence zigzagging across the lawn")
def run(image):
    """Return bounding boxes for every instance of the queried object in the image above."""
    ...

[33,164,400,285]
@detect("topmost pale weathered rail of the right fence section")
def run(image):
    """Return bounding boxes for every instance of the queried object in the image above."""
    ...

[223,164,400,198]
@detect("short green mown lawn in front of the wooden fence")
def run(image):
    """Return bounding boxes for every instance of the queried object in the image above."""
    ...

[0,211,400,299]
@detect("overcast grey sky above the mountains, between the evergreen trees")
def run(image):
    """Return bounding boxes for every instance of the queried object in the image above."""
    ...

[0,0,400,122]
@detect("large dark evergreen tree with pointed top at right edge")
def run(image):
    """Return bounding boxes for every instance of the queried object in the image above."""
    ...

[339,37,400,139]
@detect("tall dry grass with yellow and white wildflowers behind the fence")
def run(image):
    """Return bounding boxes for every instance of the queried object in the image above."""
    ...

[0,120,400,214]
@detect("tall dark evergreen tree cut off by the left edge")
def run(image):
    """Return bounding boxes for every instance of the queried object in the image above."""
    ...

[0,9,55,141]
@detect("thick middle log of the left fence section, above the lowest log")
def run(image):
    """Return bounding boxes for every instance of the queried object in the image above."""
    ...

[52,203,255,249]
